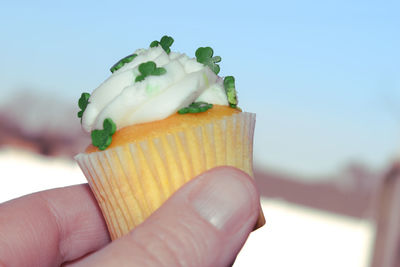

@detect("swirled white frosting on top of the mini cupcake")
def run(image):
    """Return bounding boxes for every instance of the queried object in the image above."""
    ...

[82,46,229,132]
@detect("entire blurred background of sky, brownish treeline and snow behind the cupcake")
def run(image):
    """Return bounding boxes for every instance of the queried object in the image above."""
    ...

[0,0,400,267]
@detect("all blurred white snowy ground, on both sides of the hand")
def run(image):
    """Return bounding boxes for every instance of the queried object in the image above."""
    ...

[0,149,374,267]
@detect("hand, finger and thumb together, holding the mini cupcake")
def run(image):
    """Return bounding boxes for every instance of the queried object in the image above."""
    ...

[0,167,259,267]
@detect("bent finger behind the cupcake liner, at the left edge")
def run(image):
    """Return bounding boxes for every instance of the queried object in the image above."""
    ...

[0,185,109,266]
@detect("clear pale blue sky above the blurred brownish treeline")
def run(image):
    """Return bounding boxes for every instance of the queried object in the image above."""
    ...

[0,0,400,177]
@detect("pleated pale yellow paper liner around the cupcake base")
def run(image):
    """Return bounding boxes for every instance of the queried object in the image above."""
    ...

[75,112,264,240]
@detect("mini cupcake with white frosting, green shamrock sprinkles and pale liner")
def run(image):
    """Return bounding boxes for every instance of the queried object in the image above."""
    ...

[75,36,264,240]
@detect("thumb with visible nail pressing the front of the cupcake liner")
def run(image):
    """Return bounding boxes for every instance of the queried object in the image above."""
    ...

[77,167,259,266]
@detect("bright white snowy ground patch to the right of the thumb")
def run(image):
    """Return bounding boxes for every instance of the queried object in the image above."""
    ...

[234,199,374,267]
